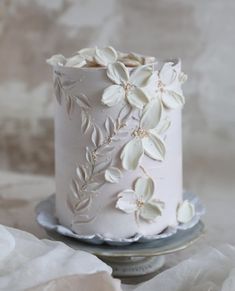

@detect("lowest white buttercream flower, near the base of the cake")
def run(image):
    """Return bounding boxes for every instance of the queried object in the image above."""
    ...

[116,178,164,221]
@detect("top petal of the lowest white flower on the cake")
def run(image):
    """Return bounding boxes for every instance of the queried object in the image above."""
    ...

[135,178,154,201]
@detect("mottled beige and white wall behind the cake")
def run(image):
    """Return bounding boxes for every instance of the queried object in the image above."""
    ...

[0,0,235,190]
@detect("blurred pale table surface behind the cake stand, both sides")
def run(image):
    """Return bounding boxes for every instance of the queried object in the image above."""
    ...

[0,171,235,268]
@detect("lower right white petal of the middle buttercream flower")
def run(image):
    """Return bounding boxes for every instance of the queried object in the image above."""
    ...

[142,132,166,161]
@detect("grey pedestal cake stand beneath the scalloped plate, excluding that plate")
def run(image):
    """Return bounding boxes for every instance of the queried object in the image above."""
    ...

[46,221,205,284]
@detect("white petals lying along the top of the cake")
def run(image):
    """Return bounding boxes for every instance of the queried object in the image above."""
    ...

[47,46,156,68]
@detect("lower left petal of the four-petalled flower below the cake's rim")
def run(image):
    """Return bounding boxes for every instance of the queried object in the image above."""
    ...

[101,85,125,107]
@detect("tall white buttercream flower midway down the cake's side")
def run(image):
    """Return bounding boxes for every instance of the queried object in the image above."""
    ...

[120,98,170,170]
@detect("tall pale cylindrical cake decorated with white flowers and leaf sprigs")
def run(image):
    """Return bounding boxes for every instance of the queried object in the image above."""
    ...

[48,47,195,240]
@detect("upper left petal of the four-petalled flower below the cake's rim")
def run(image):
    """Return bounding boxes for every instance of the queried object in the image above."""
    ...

[107,62,129,85]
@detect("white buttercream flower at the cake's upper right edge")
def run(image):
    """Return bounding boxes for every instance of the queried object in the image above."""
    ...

[151,62,186,109]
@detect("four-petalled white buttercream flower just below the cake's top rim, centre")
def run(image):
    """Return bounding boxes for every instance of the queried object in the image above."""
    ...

[102,62,152,109]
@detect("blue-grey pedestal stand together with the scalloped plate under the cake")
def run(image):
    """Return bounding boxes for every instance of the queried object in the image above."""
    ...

[36,192,205,284]
